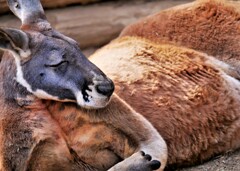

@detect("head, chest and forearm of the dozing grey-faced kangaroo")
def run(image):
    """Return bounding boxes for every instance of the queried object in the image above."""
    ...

[0,0,167,171]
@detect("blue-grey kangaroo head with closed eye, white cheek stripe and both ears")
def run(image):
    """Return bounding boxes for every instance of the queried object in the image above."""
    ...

[0,0,114,108]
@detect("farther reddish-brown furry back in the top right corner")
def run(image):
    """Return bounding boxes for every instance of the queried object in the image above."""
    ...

[121,0,240,69]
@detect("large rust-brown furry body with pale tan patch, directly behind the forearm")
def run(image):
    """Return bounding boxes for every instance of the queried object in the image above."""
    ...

[91,37,240,168]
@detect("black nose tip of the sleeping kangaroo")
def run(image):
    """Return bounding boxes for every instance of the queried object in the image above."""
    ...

[96,79,114,96]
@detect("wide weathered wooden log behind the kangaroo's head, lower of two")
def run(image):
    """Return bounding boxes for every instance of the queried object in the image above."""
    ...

[0,0,191,48]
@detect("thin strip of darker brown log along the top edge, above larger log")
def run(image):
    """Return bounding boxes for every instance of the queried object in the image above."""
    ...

[0,0,100,14]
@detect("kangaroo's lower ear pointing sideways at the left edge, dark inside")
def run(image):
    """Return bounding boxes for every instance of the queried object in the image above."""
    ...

[0,28,30,57]
